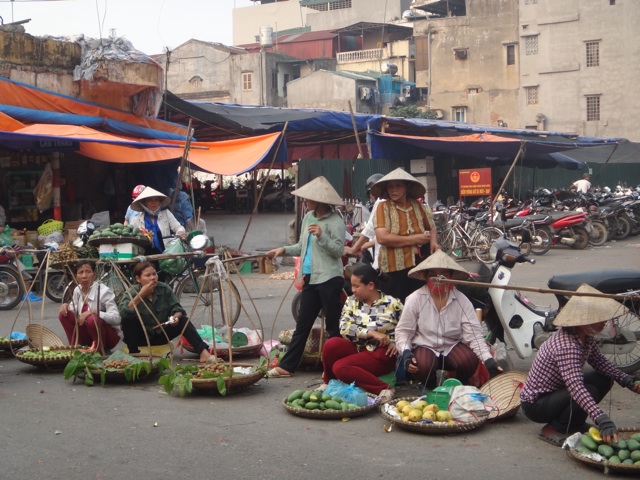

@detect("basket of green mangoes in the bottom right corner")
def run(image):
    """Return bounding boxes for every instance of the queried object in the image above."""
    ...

[568,427,640,475]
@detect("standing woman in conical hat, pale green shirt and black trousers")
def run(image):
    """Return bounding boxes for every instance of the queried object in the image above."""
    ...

[267,177,345,378]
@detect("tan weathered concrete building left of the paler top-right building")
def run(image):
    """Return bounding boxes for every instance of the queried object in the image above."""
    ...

[413,0,520,128]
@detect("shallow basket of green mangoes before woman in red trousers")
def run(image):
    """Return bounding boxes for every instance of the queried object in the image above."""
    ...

[282,390,379,420]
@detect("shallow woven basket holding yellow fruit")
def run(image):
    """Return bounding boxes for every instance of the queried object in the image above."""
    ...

[381,397,487,435]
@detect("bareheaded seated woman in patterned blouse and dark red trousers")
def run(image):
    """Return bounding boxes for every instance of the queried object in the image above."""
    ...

[319,264,402,402]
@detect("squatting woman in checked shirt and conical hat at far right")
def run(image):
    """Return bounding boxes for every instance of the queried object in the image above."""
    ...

[520,284,640,446]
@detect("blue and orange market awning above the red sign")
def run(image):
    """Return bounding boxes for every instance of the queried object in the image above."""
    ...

[367,130,583,170]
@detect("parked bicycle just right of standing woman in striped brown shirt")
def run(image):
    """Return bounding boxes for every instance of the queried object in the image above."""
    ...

[438,212,503,263]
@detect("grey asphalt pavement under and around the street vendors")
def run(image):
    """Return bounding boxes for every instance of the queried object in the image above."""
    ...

[0,214,640,480]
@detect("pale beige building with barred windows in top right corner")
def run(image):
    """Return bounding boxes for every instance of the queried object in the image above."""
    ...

[520,0,640,141]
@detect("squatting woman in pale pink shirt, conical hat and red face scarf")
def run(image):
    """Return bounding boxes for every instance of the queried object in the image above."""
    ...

[396,250,502,387]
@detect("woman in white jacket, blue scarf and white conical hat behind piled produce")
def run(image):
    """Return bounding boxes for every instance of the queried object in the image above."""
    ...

[130,187,187,254]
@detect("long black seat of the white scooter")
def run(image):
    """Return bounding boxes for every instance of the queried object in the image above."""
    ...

[547,269,640,293]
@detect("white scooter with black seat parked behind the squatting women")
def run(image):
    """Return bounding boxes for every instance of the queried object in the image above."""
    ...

[460,239,640,373]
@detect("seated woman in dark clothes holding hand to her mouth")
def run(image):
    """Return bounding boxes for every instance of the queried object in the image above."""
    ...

[118,262,217,363]
